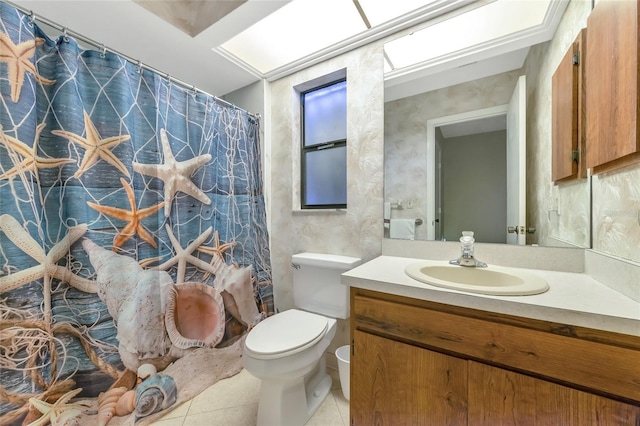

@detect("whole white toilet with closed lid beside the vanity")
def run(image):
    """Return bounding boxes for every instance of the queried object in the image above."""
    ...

[242,253,360,426]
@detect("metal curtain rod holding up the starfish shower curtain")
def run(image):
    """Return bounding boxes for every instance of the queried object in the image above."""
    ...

[2,0,260,120]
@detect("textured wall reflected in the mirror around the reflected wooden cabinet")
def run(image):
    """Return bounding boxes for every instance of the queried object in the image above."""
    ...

[523,0,591,247]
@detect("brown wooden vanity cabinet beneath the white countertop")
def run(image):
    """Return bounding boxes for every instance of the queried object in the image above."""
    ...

[350,287,640,426]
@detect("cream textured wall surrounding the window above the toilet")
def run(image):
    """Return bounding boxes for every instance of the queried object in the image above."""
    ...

[269,43,384,356]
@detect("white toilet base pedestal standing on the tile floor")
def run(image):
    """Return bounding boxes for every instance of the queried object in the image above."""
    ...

[257,356,331,426]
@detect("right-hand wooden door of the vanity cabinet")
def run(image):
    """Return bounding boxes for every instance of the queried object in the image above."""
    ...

[468,361,640,426]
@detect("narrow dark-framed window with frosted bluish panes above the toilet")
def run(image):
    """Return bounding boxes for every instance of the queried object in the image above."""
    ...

[301,79,347,209]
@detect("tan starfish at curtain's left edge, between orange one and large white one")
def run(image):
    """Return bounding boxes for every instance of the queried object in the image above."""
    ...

[0,124,73,180]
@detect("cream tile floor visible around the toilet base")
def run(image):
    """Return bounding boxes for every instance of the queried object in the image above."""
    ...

[154,368,349,426]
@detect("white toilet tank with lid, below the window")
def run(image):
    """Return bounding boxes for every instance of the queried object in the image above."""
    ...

[291,253,361,319]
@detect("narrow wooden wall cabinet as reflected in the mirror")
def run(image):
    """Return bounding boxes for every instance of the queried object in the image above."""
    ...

[551,29,587,183]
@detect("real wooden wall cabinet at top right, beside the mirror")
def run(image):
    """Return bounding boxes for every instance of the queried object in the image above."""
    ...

[585,0,640,174]
